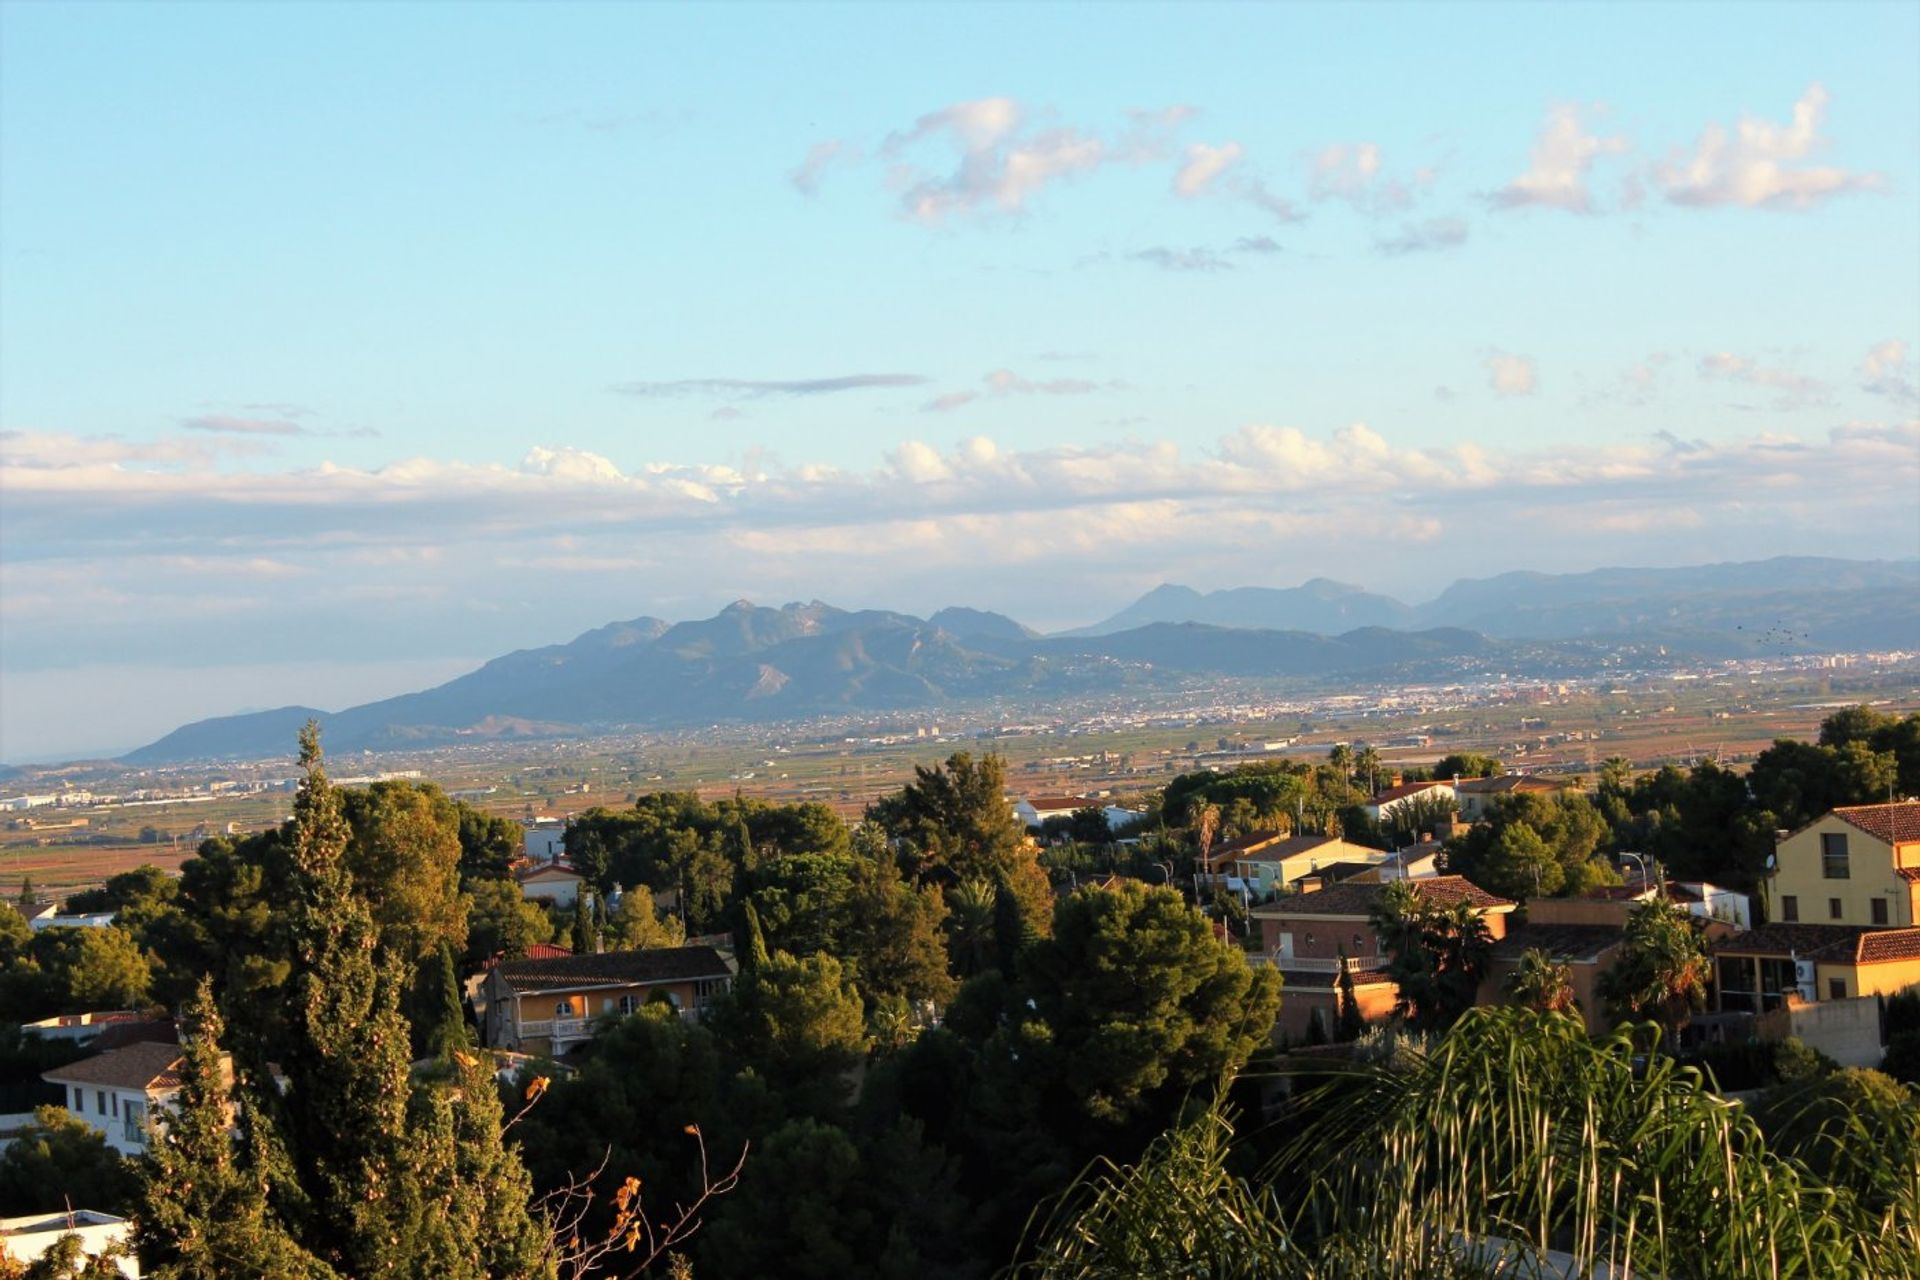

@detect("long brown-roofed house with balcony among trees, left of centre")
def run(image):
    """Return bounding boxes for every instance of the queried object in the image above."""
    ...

[484,946,733,1057]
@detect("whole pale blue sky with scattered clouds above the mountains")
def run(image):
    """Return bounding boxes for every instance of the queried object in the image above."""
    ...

[0,0,1920,762]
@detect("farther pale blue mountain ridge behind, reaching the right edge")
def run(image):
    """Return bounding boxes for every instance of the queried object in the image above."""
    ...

[1068,557,1920,656]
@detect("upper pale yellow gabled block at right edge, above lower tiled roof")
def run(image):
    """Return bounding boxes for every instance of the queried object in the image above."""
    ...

[1768,800,1920,929]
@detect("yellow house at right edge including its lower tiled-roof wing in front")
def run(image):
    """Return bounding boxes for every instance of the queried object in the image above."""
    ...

[1715,800,1920,1013]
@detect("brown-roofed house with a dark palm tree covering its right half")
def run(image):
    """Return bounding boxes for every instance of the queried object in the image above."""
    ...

[1252,875,1515,1040]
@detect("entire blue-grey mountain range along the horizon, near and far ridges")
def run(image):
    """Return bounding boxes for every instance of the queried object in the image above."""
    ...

[123,558,1920,764]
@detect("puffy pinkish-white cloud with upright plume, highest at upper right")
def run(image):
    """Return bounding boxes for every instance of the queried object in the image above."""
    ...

[1653,84,1885,209]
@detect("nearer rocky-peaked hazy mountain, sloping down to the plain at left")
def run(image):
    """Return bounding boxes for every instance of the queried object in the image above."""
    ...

[125,601,1492,764]
